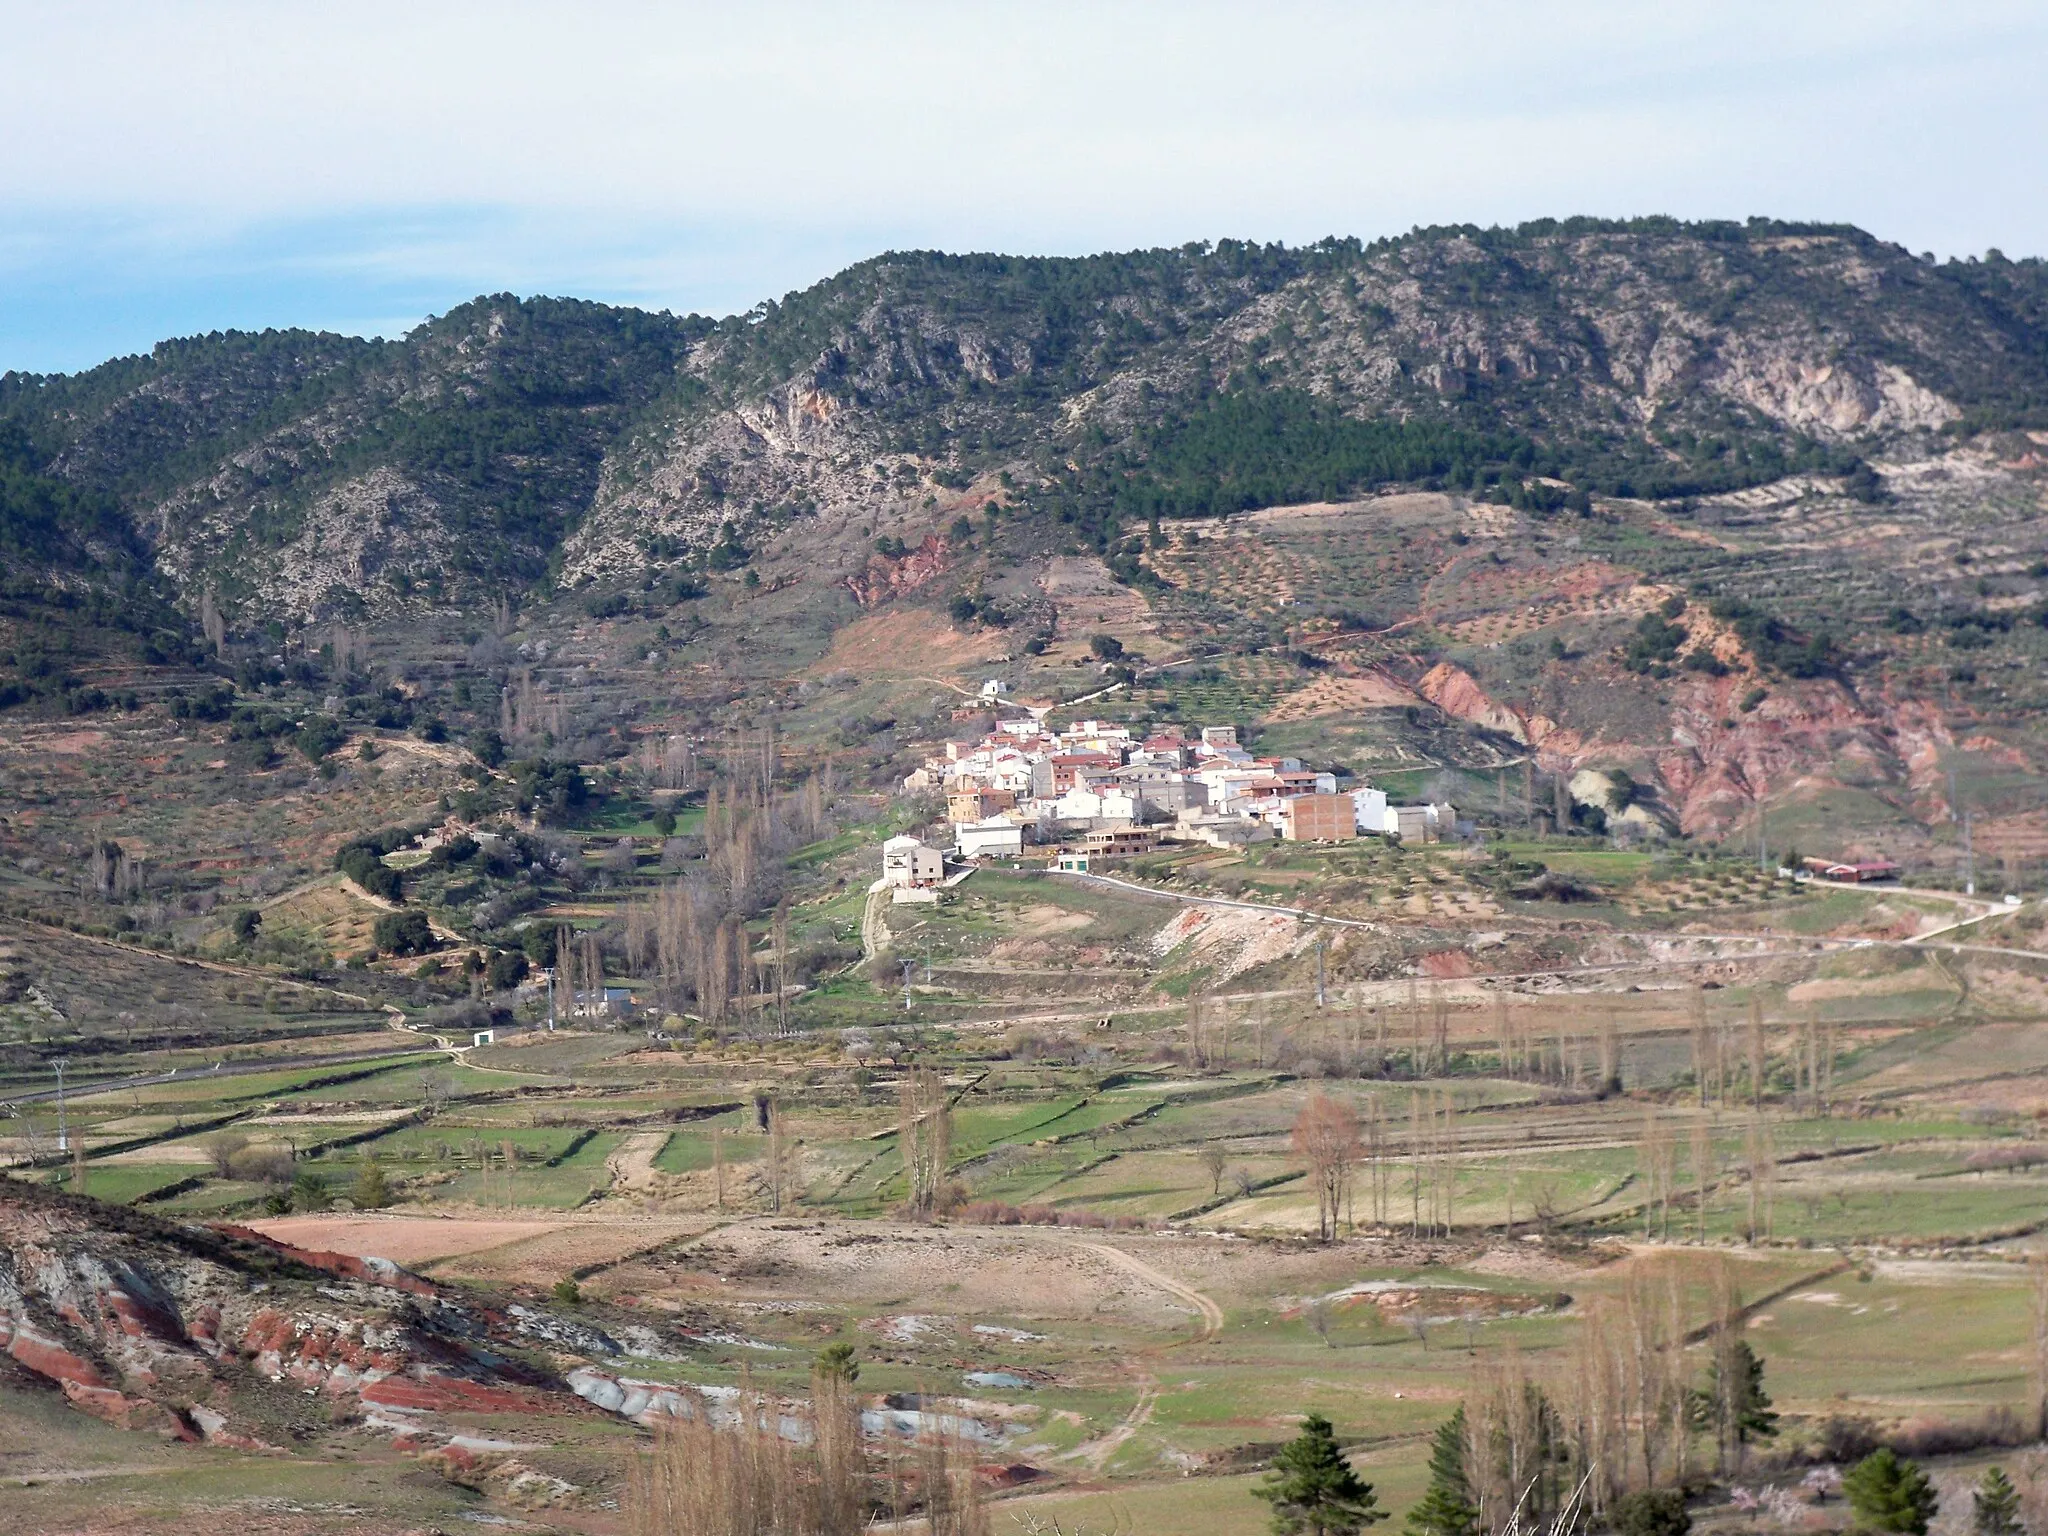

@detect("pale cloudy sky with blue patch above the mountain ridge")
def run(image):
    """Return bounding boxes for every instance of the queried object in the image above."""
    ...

[0,0,2048,373]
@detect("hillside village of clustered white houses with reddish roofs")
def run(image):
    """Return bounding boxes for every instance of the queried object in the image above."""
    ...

[877,709,1473,901]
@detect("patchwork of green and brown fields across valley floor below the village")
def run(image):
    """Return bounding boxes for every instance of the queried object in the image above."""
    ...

[23,733,2048,1534]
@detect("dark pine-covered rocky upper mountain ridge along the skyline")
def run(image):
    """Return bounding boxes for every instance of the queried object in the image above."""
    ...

[0,221,2048,623]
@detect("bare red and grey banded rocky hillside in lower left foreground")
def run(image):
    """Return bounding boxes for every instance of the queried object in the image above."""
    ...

[0,1182,593,1448]
